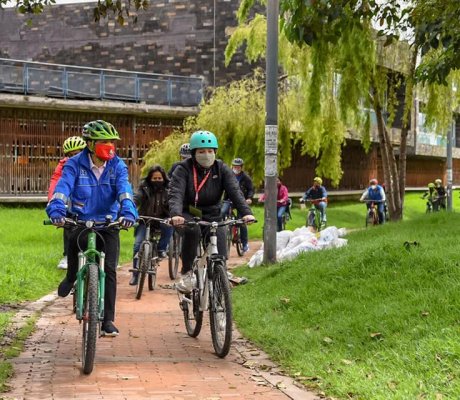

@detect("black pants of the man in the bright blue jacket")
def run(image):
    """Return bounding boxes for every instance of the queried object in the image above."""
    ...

[67,228,120,321]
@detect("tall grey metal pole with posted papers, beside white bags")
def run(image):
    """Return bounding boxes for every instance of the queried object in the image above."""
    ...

[264,0,279,264]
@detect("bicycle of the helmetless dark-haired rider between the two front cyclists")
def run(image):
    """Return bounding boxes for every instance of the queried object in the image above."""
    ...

[129,215,169,300]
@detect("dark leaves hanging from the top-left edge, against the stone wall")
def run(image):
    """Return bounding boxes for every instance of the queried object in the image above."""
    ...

[0,0,149,25]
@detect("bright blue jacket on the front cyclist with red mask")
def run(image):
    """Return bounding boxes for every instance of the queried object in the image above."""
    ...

[46,149,138,222]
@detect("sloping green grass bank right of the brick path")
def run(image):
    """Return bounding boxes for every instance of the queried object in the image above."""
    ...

[233,211,460,400]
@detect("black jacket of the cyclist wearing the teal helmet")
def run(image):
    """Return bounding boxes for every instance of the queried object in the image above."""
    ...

[169,158,252,221]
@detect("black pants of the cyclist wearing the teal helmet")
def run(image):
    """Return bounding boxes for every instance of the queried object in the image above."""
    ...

[180,217,227,274]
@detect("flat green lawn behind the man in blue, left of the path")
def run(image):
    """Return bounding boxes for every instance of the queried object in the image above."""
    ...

[0,207,134,304]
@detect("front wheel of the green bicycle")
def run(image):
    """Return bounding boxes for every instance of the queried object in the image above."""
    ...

[82,264,99,374]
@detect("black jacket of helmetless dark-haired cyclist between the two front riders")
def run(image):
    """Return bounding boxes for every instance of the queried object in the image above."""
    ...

[134,179,169,218]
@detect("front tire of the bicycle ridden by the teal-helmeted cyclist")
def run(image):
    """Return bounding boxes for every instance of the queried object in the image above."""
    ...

[209,260,232,358]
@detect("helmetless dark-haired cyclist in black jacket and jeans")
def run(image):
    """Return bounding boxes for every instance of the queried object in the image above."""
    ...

[129,165,173,285]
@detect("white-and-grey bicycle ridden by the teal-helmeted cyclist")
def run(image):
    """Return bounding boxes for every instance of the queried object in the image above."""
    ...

[177,220,256,358]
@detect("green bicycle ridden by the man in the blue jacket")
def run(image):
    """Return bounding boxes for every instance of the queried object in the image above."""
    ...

[43,218,122,375]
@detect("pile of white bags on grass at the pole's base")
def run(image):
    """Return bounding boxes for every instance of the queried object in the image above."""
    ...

[248,226,347,268]
